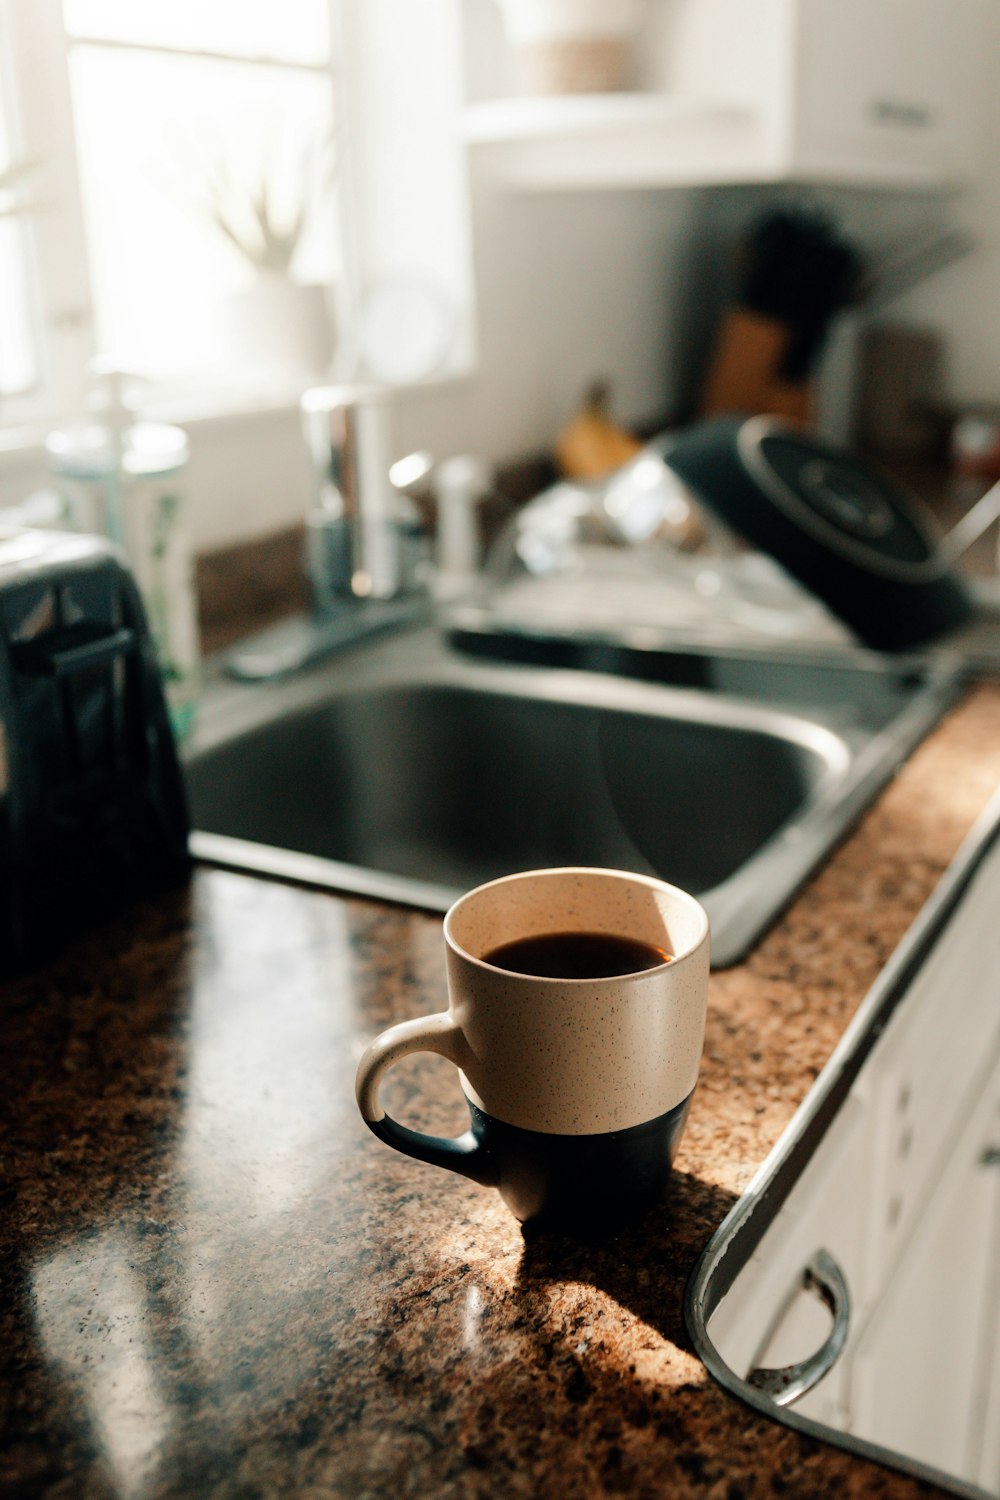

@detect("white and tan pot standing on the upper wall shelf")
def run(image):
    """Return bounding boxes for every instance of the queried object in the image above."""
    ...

[498,0,646,93]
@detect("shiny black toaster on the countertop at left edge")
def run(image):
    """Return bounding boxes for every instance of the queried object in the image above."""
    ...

[0,528,189,972]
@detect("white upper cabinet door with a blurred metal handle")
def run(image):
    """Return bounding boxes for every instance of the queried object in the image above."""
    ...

[793,0,981,177]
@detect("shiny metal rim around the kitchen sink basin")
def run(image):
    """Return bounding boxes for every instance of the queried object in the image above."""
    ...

[187,630,958,968]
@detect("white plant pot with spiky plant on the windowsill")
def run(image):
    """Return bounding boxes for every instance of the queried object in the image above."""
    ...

[223,272,333,377]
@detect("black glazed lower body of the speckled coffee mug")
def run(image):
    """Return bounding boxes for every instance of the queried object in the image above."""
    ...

[466,1095,691,1233]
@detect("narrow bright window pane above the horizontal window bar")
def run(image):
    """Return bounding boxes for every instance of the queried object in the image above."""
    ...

[63,0,330,63]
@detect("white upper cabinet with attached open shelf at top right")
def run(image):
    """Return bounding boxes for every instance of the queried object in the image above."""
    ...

[463,0,997,189]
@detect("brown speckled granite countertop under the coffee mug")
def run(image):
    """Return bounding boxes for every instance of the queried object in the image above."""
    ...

[0,684,1000,1500]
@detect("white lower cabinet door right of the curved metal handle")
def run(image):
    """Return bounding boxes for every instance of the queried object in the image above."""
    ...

[849,1068,1000,1481]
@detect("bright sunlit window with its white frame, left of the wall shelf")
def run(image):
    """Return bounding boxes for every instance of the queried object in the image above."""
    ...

[0,0,472,438]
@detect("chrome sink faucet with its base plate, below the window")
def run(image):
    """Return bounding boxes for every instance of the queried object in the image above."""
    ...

[226,386,430,681]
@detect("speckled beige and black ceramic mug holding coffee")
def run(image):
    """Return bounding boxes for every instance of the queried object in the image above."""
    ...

[357,869,709,1229]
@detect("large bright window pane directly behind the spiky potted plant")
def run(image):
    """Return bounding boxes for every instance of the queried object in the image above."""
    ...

[70,45,336,375]
